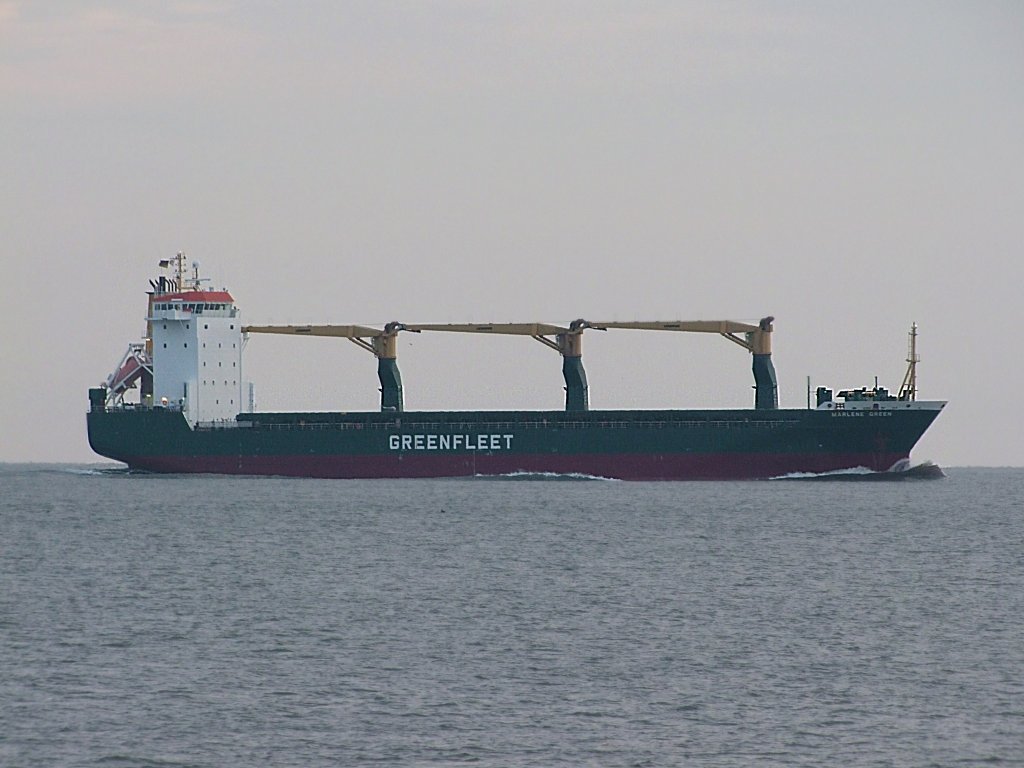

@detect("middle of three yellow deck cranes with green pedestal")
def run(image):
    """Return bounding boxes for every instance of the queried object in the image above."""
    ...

[406,319,592,412]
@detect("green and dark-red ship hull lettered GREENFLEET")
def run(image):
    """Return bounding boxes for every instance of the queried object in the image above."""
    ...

[88,408,939,480]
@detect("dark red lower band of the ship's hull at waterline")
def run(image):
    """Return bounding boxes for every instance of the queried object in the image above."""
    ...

[116,453,907,480]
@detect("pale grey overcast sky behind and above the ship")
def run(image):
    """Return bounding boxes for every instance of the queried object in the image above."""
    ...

[0,0,1024,466]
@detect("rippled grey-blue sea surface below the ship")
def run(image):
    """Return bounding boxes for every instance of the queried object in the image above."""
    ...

[0,465,1024,768]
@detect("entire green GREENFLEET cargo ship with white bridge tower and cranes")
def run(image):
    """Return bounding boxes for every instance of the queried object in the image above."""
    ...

[87,254,945,480]
